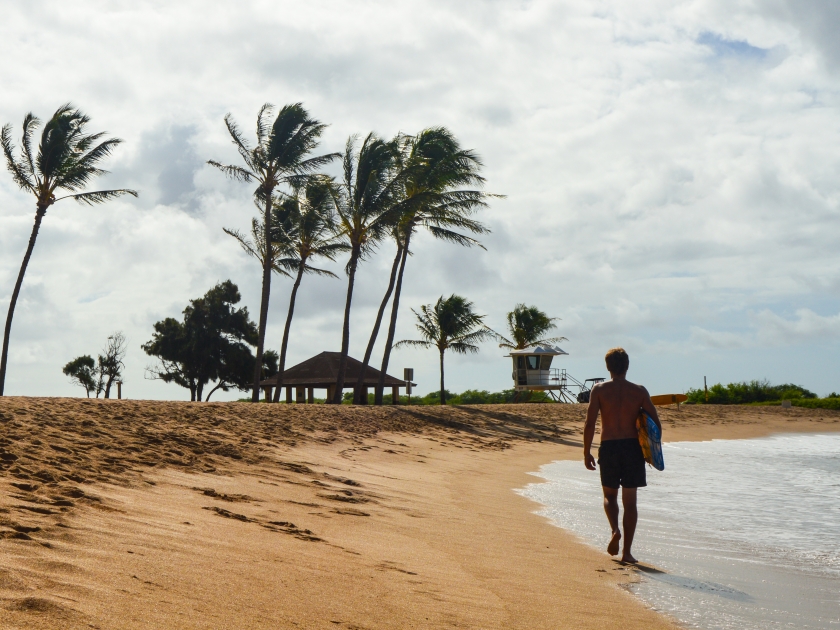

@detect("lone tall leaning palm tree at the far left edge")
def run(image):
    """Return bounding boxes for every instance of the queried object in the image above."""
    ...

[0,103,137,396]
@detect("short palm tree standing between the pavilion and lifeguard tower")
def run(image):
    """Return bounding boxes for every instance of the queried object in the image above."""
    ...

[394,294,493,405]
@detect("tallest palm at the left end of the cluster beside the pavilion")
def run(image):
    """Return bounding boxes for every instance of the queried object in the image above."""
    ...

[208,103,338,402]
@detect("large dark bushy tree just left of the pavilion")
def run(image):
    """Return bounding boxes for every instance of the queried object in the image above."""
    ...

[142,280,263,401]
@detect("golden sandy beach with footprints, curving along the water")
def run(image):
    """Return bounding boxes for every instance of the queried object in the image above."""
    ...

[0,397,840,629]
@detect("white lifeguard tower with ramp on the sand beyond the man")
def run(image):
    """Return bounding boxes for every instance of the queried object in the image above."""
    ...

[505,345,604,403]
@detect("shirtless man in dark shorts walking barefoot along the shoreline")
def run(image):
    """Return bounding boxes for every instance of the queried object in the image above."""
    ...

[583,348,662,563]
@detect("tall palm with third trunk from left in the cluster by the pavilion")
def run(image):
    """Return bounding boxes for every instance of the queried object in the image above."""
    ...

[328,133,399,404]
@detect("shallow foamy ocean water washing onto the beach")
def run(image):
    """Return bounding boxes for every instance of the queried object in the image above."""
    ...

[520,434,840,630]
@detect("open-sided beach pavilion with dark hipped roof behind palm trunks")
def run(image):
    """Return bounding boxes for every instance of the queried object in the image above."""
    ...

[260,352,416,405]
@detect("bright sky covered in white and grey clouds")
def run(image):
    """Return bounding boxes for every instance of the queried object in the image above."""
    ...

[0,0,840,399]
